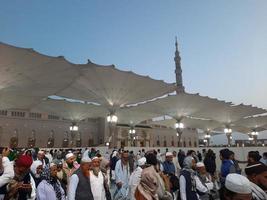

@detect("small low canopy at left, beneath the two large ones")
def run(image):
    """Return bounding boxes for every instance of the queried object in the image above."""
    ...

[31,99,107,122]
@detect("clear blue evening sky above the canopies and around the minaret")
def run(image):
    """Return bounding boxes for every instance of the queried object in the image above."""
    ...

[0,0,267,143]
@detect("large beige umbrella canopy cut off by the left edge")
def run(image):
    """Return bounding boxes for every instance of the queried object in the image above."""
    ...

[0,42,79,109]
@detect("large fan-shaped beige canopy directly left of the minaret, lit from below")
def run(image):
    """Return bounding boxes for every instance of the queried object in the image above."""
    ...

[57,62,175,109]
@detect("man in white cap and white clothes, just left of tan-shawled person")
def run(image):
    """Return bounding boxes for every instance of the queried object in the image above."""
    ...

[128,157,146,200]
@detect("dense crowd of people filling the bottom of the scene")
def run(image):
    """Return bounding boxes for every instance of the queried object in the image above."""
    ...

[0,148,267,200]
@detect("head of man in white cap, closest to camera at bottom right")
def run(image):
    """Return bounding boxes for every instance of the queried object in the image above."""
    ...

[223,174,252,200]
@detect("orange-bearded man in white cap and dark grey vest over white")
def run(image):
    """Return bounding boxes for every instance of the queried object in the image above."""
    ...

[68,156,94,200]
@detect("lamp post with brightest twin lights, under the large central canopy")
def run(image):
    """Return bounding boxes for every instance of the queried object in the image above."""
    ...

[106,112,118,147]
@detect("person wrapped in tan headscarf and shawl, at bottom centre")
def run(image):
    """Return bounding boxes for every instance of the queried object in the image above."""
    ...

[135,166,159,200]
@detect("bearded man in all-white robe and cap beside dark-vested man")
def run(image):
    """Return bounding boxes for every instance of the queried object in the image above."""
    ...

[90,157,111,200]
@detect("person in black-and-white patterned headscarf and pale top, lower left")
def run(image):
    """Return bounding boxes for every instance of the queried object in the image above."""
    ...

[37,162,66,200]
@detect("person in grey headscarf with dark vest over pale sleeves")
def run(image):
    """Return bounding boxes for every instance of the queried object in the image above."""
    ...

[179,156,199,200]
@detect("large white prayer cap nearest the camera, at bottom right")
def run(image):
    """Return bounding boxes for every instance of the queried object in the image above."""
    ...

[225,174,252,194]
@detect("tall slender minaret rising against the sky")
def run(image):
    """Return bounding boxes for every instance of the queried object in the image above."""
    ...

[174,37,184,94]
